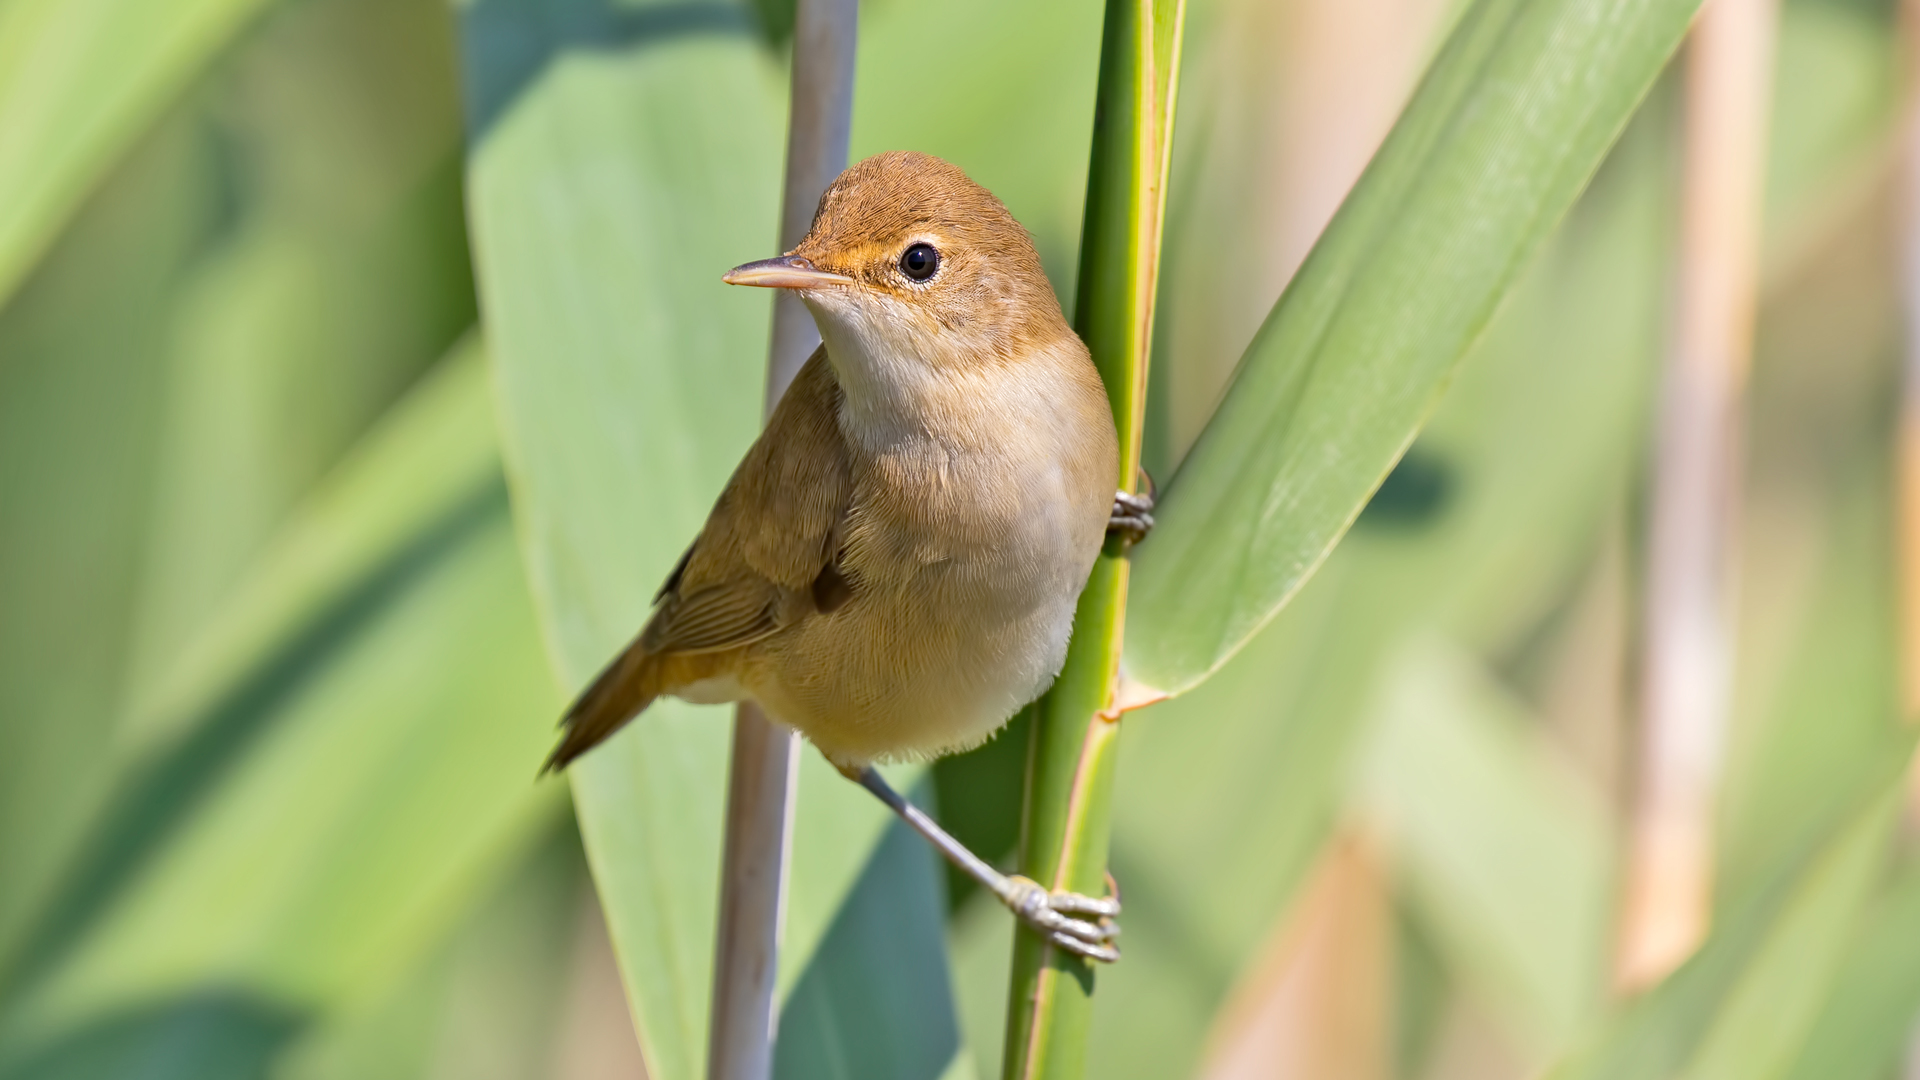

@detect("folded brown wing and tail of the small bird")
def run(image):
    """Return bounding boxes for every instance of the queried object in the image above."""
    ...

[547,346,852,769]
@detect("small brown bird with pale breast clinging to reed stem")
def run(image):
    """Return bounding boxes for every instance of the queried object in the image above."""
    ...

[547,152,1152,959]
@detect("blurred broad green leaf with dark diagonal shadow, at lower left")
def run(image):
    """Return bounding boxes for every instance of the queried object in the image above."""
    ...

[0,350,559,1061]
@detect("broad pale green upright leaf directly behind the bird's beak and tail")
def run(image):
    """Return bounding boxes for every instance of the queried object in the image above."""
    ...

[461,0,975,1080]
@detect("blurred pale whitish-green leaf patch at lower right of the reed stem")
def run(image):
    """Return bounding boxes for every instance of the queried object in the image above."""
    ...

[1357,642,1615,1057]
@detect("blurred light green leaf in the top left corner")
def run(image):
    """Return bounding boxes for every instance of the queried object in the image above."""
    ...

[0,0,263,304]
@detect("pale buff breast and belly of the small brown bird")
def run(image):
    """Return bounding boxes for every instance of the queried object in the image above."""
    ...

[756,322,1117,763]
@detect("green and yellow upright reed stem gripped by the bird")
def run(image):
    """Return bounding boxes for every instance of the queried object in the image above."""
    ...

[1006,0,1185,1080]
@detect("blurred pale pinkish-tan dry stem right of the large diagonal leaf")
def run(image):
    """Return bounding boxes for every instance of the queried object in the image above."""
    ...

[1617,0,1778,990]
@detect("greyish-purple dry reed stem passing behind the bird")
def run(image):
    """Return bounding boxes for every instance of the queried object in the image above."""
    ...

[707,0,860,1080]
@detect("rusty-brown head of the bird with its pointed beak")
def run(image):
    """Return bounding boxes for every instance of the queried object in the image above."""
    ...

[726,152,1071,369]
